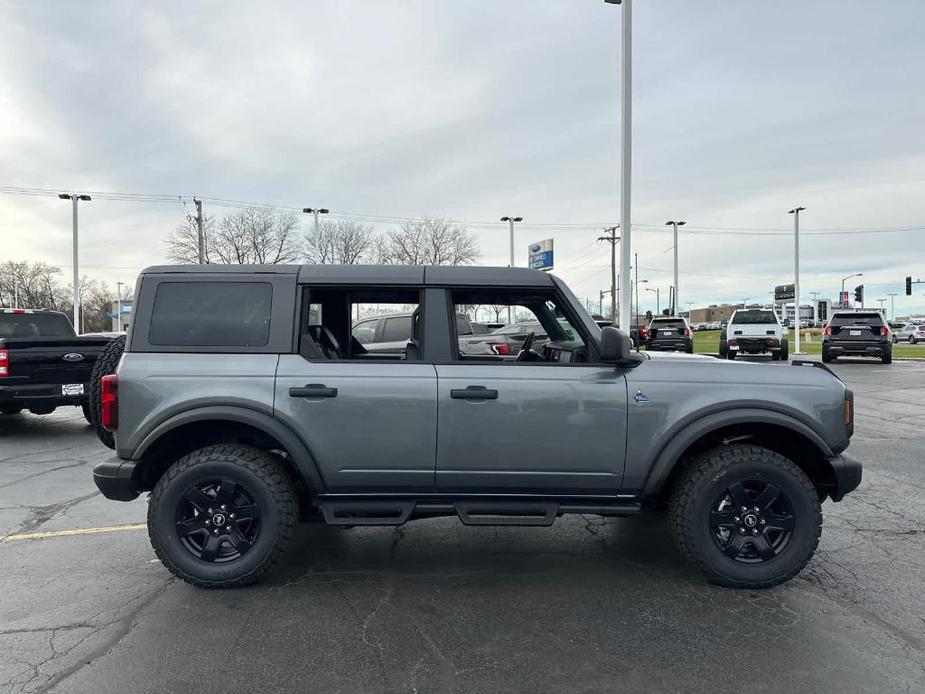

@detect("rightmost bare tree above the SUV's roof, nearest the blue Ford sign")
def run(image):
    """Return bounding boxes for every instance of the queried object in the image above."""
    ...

[377,217,480,265]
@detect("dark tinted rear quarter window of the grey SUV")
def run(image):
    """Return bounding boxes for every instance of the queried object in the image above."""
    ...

[148,282,273,347]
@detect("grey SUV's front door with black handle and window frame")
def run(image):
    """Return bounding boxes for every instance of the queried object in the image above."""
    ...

[436,288,627,494]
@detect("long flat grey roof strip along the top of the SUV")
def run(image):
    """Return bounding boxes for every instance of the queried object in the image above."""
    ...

[141,265,553,287]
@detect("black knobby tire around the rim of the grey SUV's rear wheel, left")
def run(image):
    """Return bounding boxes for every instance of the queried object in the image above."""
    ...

[148,444,298,588]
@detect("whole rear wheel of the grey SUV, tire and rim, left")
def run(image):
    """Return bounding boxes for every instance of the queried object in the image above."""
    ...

[148,445,298,588]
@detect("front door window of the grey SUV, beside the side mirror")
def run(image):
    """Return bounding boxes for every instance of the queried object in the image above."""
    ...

[451,289,588,364]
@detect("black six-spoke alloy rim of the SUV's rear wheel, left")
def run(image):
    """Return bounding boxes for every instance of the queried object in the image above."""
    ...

[175,478,261,563]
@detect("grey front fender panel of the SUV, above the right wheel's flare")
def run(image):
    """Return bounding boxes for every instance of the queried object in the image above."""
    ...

[624,355,847,490]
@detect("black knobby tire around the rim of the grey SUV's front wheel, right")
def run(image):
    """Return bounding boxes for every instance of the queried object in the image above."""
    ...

[668,446,822,588]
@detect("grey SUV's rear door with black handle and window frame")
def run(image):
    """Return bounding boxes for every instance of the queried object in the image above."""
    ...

[274,285,437,493]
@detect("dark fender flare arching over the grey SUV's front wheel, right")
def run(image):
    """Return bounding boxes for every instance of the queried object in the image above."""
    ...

[643,407,835,496]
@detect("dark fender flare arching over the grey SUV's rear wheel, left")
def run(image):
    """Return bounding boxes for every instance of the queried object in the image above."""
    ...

[127,405,325,493]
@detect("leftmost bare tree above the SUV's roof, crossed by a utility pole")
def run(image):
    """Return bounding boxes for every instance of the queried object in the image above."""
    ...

[166,207,302,265]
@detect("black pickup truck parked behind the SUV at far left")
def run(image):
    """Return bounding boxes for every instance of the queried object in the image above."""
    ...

[0,308,110,421]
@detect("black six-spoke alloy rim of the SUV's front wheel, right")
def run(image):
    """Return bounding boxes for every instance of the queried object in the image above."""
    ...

[710,479,796,564]
